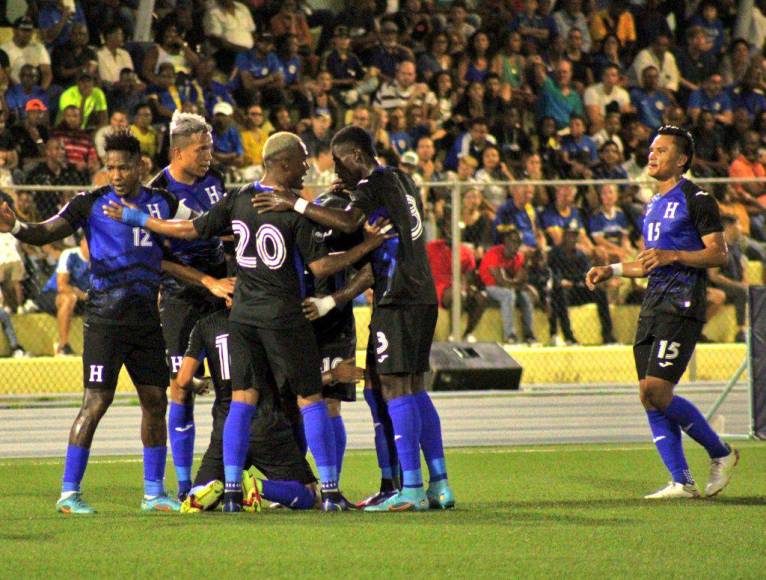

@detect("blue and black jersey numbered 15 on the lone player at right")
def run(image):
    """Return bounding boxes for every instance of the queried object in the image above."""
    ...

[641,179,723,321]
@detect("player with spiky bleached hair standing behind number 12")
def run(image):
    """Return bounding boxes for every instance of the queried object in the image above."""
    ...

[149,111,226,501]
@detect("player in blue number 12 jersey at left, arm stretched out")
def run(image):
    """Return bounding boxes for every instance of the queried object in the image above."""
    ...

[0,132,231,514]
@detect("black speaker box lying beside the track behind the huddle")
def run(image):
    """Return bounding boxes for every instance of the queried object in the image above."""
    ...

[426,342,522,391]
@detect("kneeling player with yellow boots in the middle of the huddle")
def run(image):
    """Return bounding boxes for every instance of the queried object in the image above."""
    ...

[176,310,364,512]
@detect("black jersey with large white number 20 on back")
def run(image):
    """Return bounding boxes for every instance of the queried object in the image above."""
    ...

[194,182,327,329]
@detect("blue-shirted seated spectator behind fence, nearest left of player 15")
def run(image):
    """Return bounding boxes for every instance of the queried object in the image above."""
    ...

[589,185,634,264]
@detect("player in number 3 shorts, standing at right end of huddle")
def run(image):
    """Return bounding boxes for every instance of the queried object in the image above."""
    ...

[254,126,455,511]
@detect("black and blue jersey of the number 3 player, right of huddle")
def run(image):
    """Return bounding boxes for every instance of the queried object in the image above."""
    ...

[351,167,436,306]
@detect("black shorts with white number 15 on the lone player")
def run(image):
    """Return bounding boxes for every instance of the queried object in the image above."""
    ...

[633,314,705,384]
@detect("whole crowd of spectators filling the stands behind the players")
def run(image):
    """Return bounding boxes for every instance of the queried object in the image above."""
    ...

[0,0,766,356]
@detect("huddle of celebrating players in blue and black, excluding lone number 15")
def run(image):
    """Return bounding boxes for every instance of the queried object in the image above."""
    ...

[0,113,455,513]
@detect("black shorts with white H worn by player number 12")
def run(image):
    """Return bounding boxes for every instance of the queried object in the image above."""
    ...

[82,322,170,391]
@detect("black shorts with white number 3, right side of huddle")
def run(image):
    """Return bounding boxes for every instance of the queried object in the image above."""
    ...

[367,304,438,375]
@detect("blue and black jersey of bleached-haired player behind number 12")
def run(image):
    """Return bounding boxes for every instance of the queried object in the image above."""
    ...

[149,167,226,301]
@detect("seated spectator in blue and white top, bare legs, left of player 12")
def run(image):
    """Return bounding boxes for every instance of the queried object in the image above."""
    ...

[35,236,90,356]
